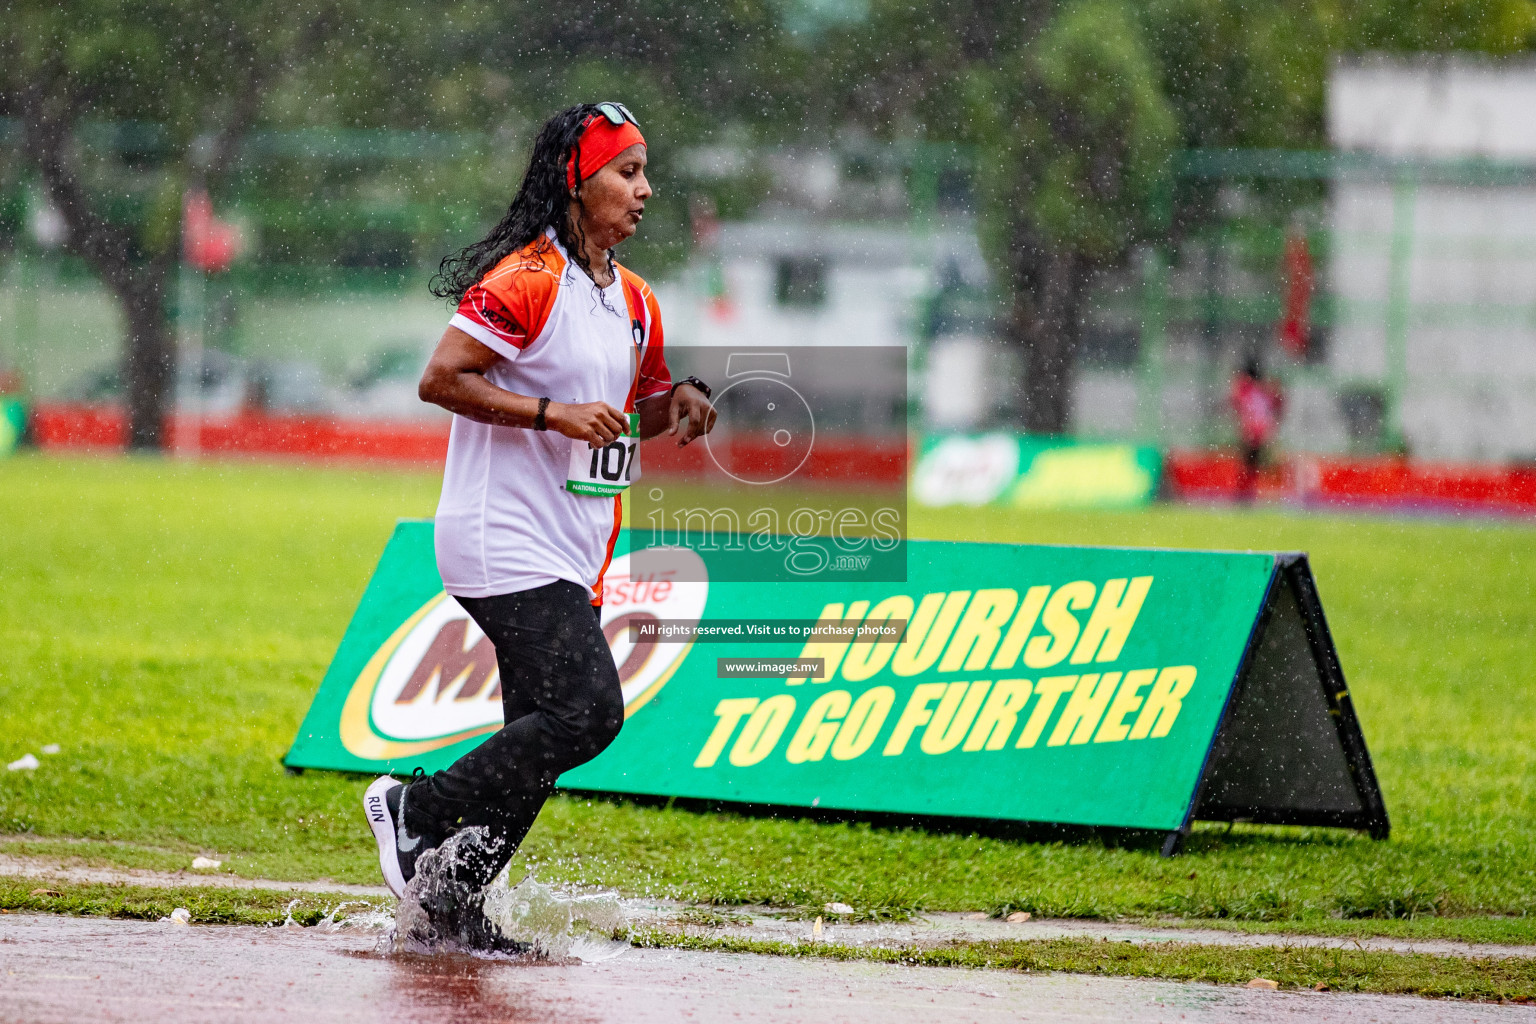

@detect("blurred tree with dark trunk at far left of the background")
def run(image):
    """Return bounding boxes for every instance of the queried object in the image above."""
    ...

[0,0,433,450]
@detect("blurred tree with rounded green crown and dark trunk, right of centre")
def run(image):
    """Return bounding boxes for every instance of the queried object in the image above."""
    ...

[968,0,1178,433]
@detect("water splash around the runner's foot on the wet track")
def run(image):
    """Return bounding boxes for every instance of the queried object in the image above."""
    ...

[378,827,628,963]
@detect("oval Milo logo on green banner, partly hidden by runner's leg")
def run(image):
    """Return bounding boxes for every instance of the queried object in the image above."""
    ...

[341,551,710,760]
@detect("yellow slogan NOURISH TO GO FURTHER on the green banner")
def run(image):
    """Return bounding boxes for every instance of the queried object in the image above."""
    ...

[694,576,1197,768]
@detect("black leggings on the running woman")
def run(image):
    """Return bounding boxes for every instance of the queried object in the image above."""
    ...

[404,580,624,884]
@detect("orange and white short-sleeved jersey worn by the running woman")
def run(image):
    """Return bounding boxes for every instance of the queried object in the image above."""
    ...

[435,232,671,597]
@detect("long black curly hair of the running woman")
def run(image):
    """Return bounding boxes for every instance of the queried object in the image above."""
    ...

[427,103,613,304]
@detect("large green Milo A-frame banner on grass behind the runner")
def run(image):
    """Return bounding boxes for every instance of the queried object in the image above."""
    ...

[286,520,1387,852]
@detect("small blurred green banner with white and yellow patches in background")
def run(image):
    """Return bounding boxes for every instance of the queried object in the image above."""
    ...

[912,433,1163,508]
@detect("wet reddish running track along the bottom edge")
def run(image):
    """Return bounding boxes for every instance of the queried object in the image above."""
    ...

[0,915,1536,1024]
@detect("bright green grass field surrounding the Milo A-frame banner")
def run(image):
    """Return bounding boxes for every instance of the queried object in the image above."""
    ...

[0,454,1536,943]
